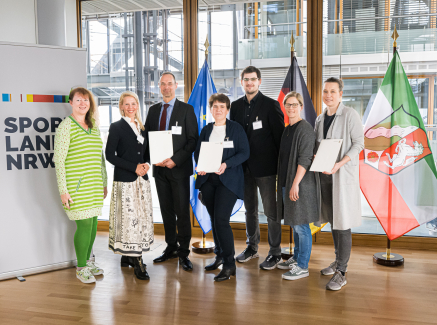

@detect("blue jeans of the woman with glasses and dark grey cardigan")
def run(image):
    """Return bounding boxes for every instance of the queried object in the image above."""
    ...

[282,187,313,269]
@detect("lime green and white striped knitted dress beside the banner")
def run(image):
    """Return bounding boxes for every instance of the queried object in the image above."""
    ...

[53,116,107,220]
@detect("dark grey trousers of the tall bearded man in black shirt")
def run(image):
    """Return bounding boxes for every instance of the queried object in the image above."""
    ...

[244,168,281,256]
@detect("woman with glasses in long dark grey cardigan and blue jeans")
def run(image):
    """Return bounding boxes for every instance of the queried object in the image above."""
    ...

[277,91,319,280]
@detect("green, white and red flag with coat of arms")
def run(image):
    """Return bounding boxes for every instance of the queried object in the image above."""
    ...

[360,52,437,240]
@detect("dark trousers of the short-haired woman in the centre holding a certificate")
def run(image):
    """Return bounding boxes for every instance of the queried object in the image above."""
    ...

[200,174,237,268]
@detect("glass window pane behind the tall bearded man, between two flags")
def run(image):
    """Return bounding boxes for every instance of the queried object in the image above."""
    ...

[198,0,307,223]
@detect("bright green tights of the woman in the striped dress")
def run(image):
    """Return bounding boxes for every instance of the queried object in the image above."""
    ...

[74,217,97,267]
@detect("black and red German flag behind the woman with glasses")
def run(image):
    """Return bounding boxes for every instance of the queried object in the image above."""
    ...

[278,57,317,127]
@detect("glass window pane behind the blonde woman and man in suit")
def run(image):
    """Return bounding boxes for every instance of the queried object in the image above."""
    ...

[82,10,184,222]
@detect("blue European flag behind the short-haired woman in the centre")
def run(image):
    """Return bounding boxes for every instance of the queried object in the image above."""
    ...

[188,60,243,234]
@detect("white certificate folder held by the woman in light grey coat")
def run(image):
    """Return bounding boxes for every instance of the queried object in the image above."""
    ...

[310,139,343,173]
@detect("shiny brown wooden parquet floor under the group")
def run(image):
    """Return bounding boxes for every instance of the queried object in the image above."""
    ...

[0,233,437,325]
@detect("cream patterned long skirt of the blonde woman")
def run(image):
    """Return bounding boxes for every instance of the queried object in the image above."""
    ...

[109,177,154,256]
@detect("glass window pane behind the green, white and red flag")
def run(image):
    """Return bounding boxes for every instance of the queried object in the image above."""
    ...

[323,0,437,236]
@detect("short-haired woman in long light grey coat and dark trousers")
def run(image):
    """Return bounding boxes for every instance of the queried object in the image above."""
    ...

[315,78,364,290]
